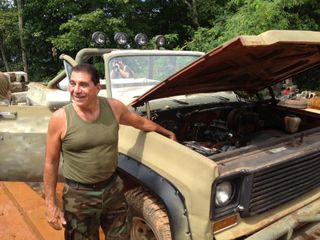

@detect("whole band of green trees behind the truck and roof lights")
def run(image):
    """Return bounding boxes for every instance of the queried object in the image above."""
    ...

[0,0,320,87]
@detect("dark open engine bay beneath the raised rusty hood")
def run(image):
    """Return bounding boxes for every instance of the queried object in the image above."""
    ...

[151,102,320,156]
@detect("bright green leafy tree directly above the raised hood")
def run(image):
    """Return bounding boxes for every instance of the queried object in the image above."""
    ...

[188,0,320,51]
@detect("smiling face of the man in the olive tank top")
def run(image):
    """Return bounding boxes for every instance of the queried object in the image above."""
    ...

[69,72,100,106]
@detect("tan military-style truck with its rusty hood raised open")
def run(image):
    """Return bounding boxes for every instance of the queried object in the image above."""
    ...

[0,30,320,240]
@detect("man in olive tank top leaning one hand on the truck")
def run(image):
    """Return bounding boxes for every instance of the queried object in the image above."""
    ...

[43,64,175,240]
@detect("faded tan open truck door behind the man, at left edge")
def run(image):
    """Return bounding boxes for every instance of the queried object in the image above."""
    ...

[0,106,51,181]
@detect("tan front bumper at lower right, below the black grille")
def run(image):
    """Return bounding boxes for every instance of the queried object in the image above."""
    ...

[246,200,320,240]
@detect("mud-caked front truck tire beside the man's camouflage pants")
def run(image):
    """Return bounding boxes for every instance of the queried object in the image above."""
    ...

[126,187,172,240]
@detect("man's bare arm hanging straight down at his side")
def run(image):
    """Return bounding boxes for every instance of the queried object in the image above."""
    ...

[43,109,66,230]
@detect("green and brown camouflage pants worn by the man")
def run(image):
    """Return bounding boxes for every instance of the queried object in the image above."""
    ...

[63,176,131,240]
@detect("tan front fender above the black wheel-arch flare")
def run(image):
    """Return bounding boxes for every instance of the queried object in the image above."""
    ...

[119,126,218,240]
